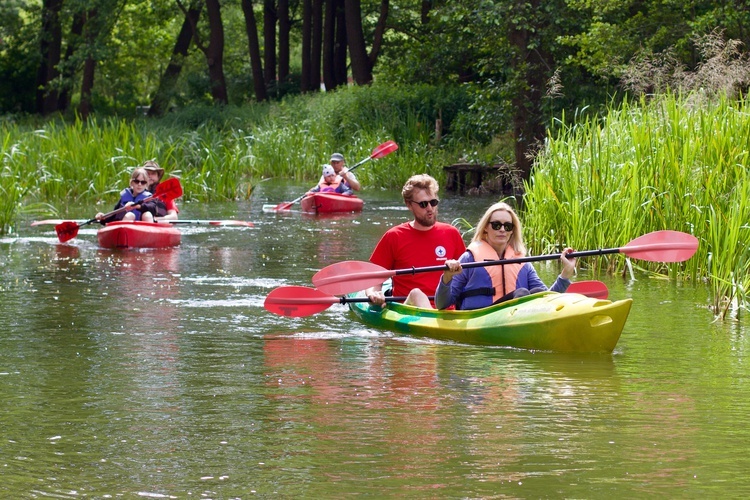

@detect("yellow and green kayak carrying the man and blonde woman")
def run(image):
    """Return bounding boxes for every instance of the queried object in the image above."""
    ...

[348,292,632,352]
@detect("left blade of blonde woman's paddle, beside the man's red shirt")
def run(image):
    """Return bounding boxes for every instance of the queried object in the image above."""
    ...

[313,260,396,295]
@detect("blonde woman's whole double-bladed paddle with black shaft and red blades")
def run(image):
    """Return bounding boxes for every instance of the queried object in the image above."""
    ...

[312,230,698,295]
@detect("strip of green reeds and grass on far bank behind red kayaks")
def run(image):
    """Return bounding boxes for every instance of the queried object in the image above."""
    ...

[0,86,463,232]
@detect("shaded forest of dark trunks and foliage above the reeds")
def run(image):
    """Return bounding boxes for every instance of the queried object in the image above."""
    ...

[0,0,750,179]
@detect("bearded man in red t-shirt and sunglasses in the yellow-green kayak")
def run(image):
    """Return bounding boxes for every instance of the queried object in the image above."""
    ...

[365,174,466,307]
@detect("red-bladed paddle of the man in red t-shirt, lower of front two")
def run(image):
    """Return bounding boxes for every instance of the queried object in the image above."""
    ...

[263,281,609,318]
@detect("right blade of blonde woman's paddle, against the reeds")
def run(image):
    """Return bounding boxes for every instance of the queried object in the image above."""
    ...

[620,230,698,262]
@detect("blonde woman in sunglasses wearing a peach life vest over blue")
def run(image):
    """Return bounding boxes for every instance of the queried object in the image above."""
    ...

[435,202,576,309]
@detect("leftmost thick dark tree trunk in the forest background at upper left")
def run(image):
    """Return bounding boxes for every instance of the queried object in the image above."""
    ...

[36,0,63,115]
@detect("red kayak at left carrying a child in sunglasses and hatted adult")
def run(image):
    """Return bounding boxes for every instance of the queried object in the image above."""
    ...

[96,222,182,248]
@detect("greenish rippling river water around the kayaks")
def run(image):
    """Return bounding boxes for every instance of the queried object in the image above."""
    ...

[0,183,750,499]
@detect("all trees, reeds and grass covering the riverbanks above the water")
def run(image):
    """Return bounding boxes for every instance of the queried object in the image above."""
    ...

[0,0,750,315]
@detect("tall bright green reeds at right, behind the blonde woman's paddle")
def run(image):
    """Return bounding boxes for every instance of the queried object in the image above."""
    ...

[524,94,750,316]
